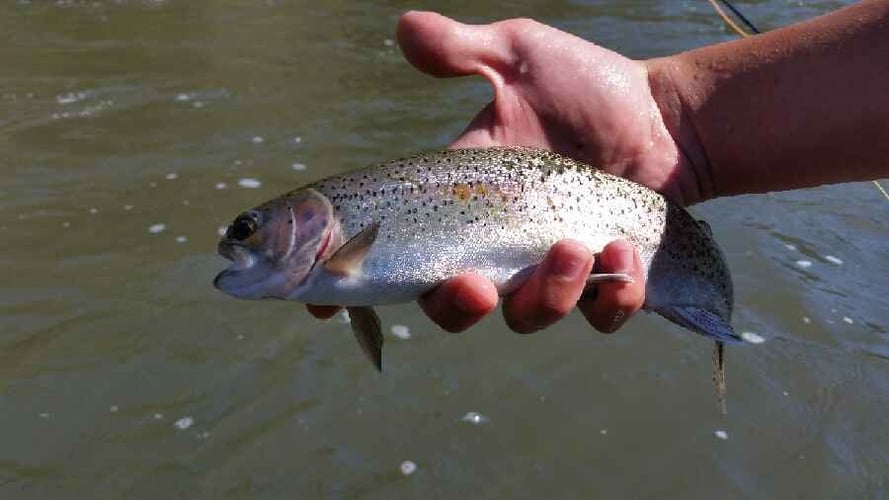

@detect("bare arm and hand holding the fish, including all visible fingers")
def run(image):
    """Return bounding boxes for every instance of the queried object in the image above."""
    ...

[310,0,889,333]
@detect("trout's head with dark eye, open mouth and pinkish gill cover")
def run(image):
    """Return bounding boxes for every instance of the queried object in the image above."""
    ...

[213,189,341,299]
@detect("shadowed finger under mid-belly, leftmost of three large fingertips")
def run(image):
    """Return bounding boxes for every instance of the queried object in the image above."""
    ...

[419,274,499,333]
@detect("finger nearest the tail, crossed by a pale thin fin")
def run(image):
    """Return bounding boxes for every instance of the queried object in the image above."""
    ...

[577,240,645,333]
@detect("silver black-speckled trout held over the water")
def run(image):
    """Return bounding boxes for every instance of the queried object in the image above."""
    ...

[214,147,741,408]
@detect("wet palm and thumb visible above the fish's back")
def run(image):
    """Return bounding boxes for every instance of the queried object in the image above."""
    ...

[398,12,700,204]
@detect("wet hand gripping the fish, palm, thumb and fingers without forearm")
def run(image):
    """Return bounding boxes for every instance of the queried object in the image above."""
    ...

[398,12,681,333]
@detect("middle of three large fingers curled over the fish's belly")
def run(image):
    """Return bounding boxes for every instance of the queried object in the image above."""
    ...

[503,240,593,333]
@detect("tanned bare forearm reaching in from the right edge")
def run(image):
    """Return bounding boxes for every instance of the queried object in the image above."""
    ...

[648,0,889,200]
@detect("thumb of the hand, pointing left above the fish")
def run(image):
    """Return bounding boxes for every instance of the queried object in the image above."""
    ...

[398,11,511,79]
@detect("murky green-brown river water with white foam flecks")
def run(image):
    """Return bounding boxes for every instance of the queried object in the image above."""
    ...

[0,0,889,499]
